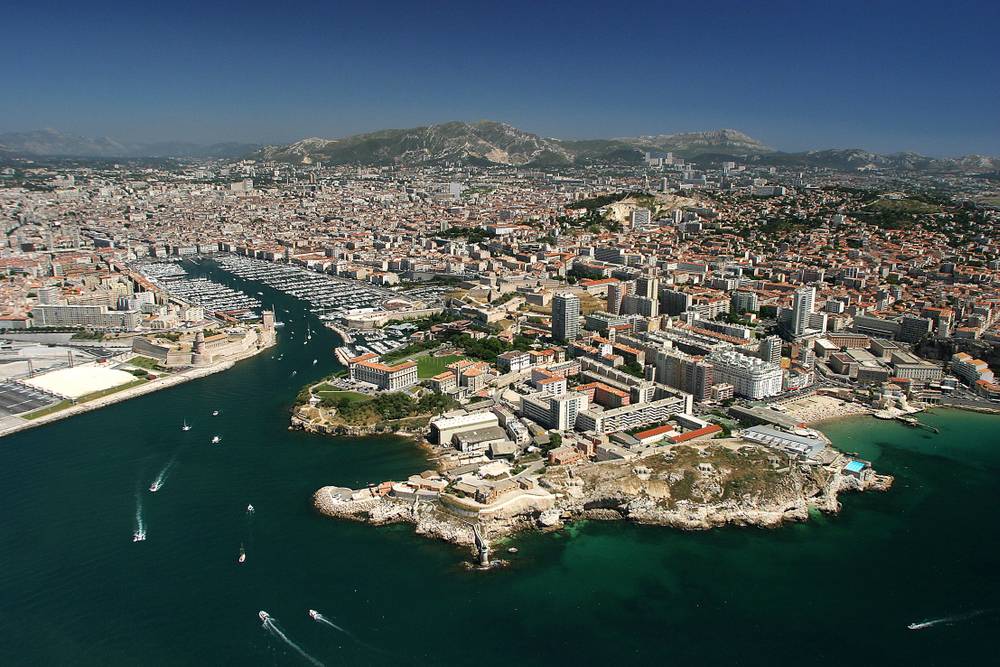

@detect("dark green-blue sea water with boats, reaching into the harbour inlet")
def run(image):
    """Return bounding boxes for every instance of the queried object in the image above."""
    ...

[0,260,1000,665]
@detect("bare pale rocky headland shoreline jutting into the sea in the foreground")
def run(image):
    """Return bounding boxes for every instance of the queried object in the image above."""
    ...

[313,443,893,560]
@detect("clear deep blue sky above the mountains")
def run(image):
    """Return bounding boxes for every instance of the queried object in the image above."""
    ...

[0,0,1000,156]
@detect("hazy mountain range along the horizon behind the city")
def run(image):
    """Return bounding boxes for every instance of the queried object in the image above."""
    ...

[0,120,1000,173]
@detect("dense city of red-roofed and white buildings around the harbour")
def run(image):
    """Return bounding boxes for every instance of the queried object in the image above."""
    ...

[0,134,1000,544]
